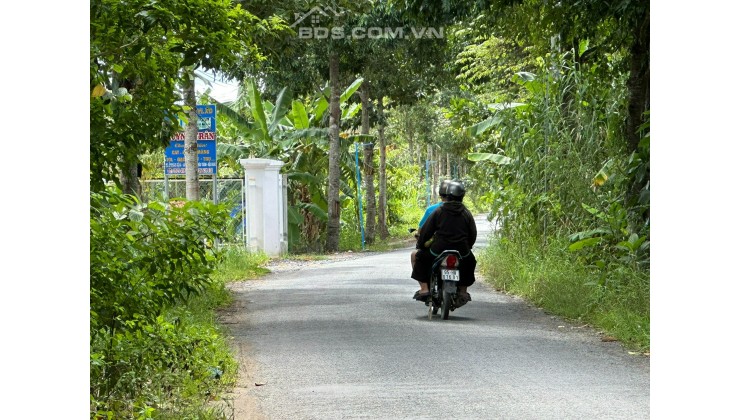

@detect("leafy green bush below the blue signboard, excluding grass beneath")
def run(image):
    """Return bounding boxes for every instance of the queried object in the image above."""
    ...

[90,189,229,331]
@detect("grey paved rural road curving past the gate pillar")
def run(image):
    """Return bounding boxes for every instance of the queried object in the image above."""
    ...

[221,218,650,420]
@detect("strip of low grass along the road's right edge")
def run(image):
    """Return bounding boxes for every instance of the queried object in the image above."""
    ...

[479,239,650,353]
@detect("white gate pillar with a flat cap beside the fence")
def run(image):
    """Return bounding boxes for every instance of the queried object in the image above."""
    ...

[239,159,288,257]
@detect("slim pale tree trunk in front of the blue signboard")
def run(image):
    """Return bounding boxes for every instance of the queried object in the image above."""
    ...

[183,68,200,201]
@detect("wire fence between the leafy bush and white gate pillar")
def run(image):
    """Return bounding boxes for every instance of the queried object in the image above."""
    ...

[141,179,246,247]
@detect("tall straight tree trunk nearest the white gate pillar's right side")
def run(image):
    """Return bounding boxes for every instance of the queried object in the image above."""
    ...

[326,54,341,252]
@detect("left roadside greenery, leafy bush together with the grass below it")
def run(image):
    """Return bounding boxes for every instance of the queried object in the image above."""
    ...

[90,189,236,418]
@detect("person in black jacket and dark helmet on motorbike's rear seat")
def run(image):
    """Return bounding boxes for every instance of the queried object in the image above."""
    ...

[411,181,478,302]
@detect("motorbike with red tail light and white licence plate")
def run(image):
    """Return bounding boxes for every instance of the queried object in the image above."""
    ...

[409,229,467,320]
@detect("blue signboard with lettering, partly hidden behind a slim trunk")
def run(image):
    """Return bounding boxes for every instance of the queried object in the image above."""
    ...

[164,105,218,175]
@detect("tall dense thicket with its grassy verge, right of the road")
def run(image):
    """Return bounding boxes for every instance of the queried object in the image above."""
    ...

[467,26,650,348]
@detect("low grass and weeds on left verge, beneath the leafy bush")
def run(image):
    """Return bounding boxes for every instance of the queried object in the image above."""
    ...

[90,280,238,420]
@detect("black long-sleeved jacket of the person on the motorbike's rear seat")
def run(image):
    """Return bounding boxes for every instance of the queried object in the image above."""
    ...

[416,201,478,256]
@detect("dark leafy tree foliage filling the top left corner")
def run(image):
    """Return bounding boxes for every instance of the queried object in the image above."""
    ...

[90,0,284,191]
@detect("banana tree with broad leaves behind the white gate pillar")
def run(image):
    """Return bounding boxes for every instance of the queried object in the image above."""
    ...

[212,79,362,249]
